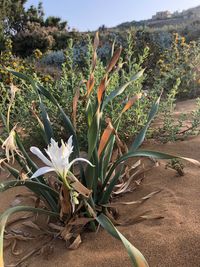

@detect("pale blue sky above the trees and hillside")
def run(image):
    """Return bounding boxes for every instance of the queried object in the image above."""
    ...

[26,0,200,31]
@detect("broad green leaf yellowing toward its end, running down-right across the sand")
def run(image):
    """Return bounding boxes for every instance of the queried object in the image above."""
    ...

[96,214,149,267]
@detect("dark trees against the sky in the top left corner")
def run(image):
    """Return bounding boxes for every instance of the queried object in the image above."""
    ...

[0,0,69,56]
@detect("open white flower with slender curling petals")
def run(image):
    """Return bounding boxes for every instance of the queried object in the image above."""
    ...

[30,136,93,180]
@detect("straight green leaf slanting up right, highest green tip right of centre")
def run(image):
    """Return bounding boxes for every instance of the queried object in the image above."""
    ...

[101,69,144,111]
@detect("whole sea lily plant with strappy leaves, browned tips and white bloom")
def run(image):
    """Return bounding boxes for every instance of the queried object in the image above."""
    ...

[0,33,199,267]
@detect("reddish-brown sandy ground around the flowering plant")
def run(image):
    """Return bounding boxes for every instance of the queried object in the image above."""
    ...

[1,101,200,267]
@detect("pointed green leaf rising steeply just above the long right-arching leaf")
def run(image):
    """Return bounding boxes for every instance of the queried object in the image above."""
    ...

[130,95,161,151]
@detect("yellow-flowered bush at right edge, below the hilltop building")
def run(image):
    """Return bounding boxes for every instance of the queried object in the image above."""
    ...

[154,33,200,99]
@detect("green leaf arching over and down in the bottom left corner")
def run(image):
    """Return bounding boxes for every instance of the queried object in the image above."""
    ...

[0,206,59,267]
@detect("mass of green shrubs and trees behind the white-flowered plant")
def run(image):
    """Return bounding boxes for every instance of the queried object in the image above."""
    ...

[0,1,200,151]
